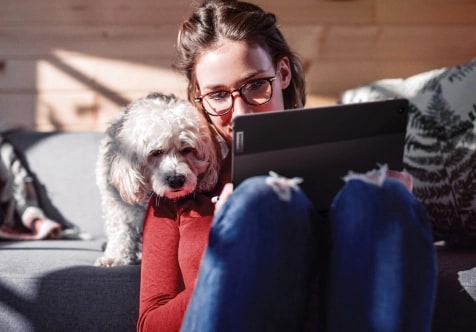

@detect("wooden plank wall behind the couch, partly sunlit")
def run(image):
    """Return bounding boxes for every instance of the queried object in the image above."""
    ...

[0,0,476,130]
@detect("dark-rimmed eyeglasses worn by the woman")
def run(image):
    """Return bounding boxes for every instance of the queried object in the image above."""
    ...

[195,75,276,116]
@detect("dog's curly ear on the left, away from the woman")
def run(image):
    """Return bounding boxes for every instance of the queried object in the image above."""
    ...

[109,151,149,204]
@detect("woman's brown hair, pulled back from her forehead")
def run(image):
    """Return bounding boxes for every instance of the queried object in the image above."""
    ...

[174,0,306,108]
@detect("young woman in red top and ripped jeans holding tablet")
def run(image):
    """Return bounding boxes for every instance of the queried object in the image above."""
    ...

[137,0,435,332]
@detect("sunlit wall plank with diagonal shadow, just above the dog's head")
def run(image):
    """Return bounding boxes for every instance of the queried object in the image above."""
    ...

[0,51,186,95]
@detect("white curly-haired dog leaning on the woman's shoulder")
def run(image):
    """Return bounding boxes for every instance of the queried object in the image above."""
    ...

[95,93,220,267]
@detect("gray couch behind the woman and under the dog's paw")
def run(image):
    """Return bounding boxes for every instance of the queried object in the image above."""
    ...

[0,128,476,332]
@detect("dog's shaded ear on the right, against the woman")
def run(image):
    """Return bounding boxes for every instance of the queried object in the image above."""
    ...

[197,134,221,192]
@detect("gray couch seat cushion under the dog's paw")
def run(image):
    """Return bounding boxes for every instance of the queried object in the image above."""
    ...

[0,240,140,332]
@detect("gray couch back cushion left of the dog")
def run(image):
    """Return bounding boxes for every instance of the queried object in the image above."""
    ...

[7,131,104,236]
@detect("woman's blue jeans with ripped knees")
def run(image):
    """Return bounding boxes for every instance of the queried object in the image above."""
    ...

[182,170,436,332]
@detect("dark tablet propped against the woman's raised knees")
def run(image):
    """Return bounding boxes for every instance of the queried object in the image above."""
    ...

[232,99,409,211]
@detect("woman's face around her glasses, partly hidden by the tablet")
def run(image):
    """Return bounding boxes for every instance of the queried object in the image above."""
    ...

[195,40,291,145]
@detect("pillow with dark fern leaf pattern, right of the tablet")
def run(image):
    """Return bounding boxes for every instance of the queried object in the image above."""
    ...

[340,59,476,246]
